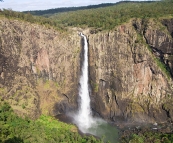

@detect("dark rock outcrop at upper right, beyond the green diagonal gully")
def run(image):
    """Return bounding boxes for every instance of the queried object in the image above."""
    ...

[144,19,173,76]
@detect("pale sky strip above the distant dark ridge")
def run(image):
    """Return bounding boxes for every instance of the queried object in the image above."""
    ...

[0,0,119,11]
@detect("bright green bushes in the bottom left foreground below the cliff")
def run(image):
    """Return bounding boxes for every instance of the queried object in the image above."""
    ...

[0,102,102,143]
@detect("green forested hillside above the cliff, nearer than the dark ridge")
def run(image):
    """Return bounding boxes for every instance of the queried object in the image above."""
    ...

[50,1,173,30]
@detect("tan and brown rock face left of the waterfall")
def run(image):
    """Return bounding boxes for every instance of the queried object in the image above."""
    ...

[0,19,80,118]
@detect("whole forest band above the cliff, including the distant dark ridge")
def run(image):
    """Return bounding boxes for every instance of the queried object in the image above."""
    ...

[0,0,173,31]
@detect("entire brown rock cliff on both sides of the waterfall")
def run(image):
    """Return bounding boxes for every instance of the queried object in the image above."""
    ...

[0,19,173,122]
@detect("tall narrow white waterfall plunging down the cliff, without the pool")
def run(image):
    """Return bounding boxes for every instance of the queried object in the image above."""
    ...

[75,33,93,133]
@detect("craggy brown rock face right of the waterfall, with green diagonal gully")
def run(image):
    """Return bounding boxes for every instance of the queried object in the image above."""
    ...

[89,19,173,122]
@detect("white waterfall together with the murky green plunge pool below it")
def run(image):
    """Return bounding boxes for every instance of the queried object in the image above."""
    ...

[69,33,118,143]
